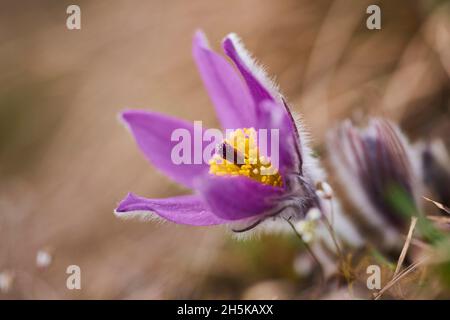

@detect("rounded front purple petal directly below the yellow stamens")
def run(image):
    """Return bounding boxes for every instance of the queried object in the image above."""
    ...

[197,176,284,220]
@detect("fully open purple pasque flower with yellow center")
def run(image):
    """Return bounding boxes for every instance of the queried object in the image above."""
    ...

[115,31,317,231]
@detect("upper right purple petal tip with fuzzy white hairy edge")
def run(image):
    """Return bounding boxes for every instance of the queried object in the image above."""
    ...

[222,34,280,105]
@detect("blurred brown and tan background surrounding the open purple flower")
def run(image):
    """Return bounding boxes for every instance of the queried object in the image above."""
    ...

[0,0,450,299]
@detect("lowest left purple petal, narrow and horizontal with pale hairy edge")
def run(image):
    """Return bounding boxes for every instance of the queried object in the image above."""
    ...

[115,193,227,226]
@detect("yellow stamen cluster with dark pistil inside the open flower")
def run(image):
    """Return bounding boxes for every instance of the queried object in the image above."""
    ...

[209,128,283,187]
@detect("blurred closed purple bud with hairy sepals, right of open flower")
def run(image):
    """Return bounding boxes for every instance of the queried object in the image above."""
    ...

[328,118,420,241]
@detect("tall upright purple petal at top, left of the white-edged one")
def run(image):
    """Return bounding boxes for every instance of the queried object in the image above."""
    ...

[192,31,255,129]
